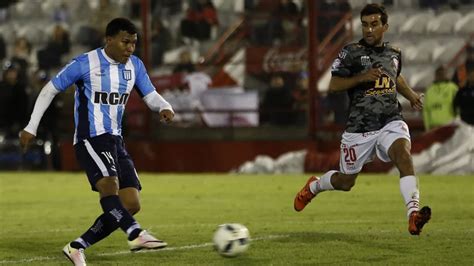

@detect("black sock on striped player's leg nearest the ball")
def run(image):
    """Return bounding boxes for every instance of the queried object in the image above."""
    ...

[100,195,141,239]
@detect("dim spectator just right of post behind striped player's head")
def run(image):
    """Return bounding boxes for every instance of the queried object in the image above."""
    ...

[151,18,172,67]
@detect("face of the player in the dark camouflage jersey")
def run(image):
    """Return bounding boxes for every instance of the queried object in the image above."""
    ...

[361,14,388,46]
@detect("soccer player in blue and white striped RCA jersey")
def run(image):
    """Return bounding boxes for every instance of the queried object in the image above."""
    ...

[20,18,174,265]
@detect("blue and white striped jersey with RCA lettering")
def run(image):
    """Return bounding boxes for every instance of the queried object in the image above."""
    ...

[51,48,155,144]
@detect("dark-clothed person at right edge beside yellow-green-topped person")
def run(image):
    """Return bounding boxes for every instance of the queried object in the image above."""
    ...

[453,68,474,124]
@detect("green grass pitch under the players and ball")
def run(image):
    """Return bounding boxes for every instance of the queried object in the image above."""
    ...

[0,172,474,265]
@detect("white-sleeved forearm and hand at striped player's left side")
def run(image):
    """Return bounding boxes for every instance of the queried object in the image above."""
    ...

[20,81,59,151]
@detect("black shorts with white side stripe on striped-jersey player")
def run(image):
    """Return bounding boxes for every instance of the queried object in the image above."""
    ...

[74,134,142,191]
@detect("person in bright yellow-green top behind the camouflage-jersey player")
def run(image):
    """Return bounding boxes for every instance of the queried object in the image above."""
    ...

[423,66,458,131]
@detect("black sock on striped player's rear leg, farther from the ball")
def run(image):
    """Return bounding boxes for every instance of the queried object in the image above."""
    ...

[77,213,119,248]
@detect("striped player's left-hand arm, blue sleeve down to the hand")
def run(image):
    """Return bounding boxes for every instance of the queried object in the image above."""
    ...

[20,58,82,152]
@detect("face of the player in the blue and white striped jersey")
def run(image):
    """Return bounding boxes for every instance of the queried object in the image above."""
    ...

[106,31,138,64]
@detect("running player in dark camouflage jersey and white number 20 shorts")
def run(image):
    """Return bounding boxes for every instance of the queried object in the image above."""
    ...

[294,4,431,235]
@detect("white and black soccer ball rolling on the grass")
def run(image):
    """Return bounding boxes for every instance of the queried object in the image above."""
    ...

[213,224,250,257]
